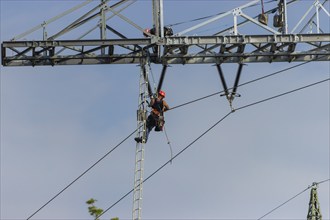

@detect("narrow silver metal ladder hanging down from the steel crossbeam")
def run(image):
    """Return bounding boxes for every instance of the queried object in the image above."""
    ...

[132,58,150,220]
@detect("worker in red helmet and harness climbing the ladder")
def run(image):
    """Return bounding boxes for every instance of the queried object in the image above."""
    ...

[135,90,170,143]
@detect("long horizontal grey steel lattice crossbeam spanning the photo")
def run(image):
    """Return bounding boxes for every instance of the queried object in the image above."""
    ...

[1,34,330,66]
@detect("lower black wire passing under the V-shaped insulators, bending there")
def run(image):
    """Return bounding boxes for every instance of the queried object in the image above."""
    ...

[95,78,330,220]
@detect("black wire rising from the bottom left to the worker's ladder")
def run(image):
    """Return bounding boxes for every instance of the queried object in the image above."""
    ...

[27,127,140,220]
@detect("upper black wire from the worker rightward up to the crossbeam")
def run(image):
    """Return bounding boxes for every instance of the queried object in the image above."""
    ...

[168,56,324,111]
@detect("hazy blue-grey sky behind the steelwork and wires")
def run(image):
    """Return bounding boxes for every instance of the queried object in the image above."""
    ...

[1,0,330,219]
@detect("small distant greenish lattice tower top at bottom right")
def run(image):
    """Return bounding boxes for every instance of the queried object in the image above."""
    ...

[307,183,322,220]
